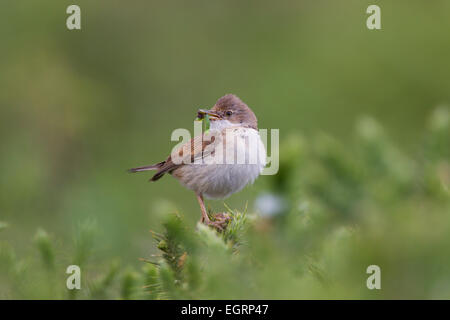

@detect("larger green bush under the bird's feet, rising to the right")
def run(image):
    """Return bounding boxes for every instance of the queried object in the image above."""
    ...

[138,110,450,299]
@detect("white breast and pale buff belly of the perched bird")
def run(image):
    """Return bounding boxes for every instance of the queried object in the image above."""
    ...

[173,127,266,199]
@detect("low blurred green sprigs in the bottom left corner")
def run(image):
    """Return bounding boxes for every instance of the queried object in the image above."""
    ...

[0,220,144,299]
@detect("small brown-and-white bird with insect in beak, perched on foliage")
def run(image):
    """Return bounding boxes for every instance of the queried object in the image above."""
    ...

[129,94,267,230]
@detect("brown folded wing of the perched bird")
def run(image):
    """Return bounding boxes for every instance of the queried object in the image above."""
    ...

[150,131,221,181]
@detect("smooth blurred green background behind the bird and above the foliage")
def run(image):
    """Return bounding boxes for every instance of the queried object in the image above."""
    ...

[0,0,450,298]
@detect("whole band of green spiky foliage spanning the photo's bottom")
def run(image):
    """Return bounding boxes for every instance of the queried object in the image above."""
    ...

[0,108,450,299]
